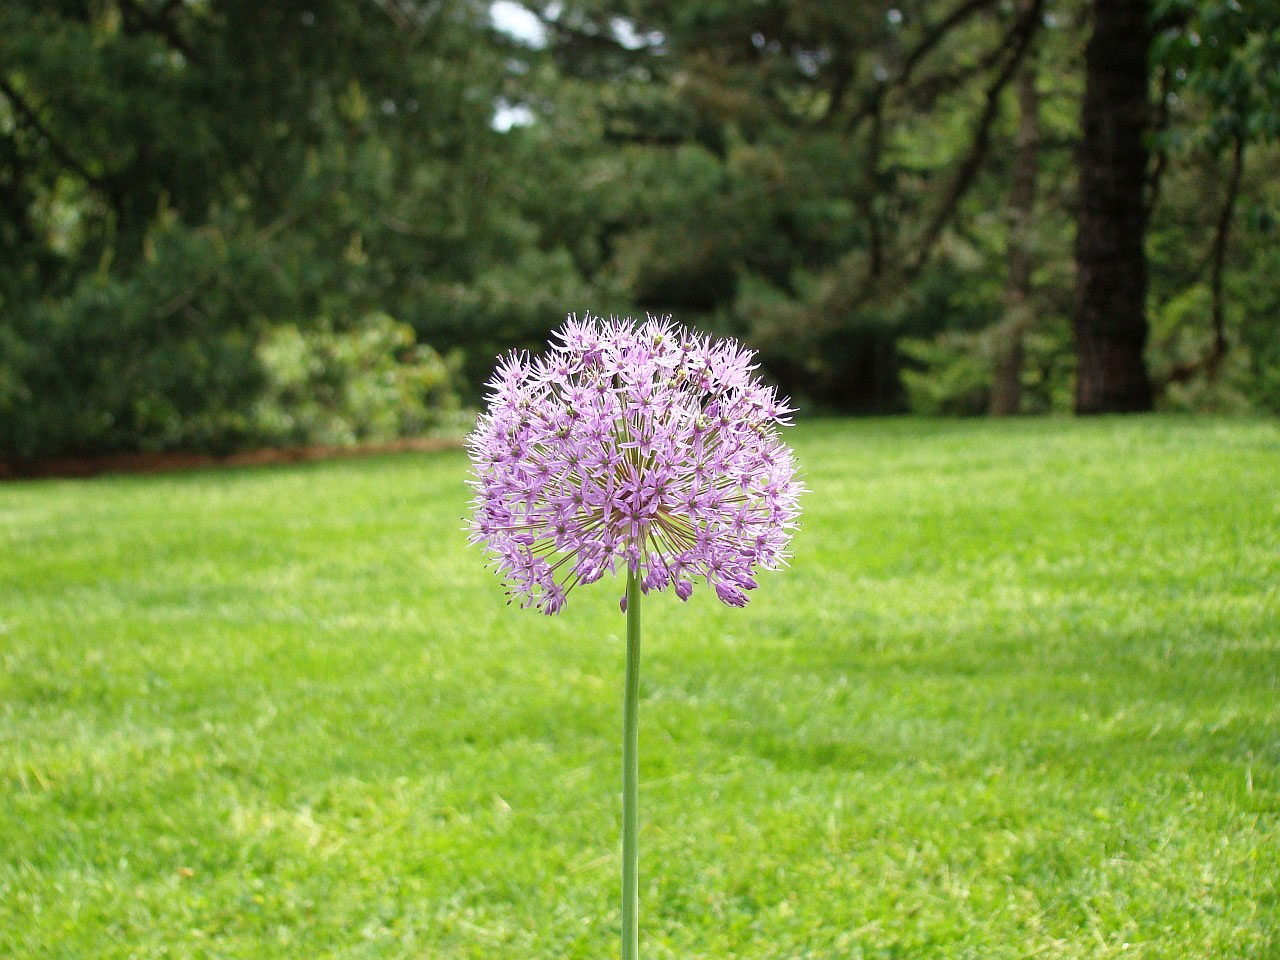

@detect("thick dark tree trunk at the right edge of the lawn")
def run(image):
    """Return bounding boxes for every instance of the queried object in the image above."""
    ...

[1075,0,1152,413]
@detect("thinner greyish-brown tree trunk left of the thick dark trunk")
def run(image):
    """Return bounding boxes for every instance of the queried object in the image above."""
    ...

[991,18,1039,416]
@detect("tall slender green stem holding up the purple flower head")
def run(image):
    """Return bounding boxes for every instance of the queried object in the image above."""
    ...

[622,572,640,960]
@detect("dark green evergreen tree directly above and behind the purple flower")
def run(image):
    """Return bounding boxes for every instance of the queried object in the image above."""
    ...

[522,0,1044,412]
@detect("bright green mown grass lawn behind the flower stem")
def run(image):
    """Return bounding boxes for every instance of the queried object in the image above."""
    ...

[0,419,1280,960]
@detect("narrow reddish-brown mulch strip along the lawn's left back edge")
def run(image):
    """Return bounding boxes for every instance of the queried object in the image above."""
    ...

[0,436,462,480]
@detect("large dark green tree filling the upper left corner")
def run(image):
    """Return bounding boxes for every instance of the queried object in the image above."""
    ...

[0,0,512,458]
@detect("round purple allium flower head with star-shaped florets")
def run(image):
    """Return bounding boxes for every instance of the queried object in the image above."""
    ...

[467,315,803,613]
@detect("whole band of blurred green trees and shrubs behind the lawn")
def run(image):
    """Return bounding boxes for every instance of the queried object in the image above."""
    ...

[0,0,1280,457]
